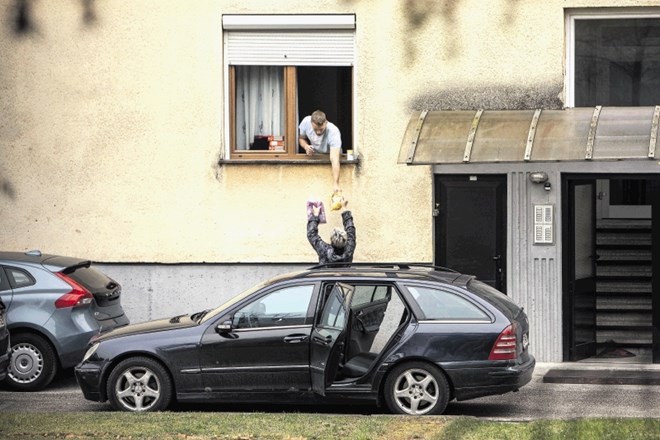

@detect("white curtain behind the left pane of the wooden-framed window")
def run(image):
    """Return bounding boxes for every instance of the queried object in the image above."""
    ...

[236,66,284,150]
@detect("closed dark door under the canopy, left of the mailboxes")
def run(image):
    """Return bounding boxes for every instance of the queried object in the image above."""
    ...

[434,175,506,293]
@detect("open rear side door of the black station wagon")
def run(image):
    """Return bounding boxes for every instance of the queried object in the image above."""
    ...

[310,283,354,396]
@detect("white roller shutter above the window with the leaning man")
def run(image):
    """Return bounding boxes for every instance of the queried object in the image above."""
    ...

[223,15,355,66]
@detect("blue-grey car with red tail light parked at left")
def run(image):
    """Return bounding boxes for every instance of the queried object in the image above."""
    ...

[0,251,129,391]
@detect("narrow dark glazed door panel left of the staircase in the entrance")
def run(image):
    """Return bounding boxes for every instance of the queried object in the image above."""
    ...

[563,179,596,361]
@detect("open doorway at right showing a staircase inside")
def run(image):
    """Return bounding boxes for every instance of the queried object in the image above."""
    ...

[562,175,660,363]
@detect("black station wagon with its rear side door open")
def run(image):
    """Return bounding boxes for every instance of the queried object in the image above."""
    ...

[75,263,535,415]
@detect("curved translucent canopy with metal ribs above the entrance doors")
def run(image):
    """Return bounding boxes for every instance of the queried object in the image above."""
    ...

[398,106,660,165]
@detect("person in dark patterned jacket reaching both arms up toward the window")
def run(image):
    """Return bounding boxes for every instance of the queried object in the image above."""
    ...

[307,200,356,264]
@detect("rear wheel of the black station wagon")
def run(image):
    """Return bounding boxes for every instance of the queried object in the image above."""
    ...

[384,362,449,416]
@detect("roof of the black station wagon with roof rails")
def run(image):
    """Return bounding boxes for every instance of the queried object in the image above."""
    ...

[289,263,474,286]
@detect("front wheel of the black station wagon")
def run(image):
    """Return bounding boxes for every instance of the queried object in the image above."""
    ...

[107,357,172,412]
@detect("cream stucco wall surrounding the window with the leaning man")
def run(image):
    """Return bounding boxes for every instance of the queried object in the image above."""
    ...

[0,0,600,263]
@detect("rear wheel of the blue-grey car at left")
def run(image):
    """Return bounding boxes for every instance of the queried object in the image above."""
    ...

[5,333,58,391]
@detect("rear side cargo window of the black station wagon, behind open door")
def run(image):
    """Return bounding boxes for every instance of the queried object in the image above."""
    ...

[407,286,490,322]
